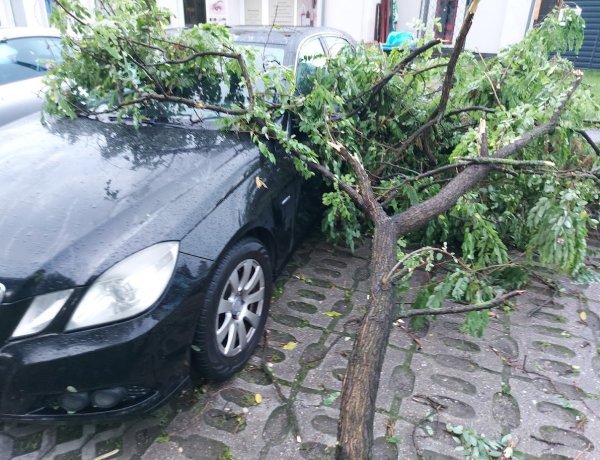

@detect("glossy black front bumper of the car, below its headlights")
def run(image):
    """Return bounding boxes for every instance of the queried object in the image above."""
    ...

[0,256,212,421]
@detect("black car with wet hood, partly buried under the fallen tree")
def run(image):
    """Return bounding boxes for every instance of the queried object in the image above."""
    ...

[0,28,350,421]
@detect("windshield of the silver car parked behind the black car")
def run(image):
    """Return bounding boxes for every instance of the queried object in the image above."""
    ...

[0,37,60,85]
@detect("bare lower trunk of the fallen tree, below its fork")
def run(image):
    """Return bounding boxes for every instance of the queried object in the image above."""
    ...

[336,219,397,460]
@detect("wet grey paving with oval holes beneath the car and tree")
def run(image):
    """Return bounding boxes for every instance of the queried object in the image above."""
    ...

[0,237,600,460]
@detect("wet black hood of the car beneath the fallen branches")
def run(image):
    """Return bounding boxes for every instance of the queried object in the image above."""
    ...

[0,115,260,302]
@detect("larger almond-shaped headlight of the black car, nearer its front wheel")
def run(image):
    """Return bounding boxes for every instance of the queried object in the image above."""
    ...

[67,241,179,330]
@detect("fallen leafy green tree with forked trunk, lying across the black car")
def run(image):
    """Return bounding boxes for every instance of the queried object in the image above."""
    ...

[46,0,600,459]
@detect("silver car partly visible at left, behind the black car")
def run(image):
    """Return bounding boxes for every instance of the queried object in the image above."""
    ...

[0,27,60,126]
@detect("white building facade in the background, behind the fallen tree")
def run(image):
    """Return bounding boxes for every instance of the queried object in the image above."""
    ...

[0,0,600,68]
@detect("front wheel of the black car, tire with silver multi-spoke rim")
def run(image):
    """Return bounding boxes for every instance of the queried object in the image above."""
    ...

[192,238,273,380]
